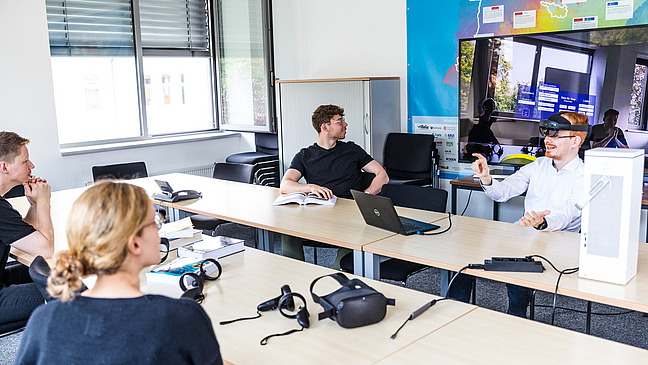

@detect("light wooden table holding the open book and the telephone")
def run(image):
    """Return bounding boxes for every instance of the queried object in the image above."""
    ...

[132,174,440,276]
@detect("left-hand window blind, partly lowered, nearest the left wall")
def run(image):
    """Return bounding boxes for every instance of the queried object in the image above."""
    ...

[46,0,133,55]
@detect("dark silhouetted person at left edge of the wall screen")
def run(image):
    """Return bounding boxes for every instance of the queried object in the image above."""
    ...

[466,98,499,161]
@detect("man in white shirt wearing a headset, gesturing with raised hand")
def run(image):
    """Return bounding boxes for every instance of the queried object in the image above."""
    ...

[448,112,588,317]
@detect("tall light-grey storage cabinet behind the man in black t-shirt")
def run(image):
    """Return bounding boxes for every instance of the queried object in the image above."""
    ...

[276,77,400,175]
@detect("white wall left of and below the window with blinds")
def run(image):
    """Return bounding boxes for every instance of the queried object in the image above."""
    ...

[0,0,253,190]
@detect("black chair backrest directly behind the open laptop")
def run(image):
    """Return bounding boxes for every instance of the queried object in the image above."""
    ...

[380,184,448,213]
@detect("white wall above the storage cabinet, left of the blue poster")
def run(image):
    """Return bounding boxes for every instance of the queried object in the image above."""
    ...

[273,0,407,131]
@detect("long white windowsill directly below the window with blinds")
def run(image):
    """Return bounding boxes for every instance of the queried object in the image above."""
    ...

[61,131,241,156]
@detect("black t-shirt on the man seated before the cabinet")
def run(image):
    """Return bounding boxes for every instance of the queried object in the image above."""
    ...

[290,141,373,198]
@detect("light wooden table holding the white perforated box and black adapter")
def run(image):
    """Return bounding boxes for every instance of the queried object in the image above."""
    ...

[363,216,648,312]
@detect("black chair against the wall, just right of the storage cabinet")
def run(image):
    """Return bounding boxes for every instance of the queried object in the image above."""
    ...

[383,133,438,185]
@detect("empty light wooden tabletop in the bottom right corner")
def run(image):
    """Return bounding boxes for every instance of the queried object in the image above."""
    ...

[378,308,648,365]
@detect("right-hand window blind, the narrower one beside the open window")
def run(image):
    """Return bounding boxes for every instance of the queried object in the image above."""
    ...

[139,0,209,50]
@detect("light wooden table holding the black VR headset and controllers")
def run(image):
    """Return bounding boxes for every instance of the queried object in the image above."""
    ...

[146,247,475,364]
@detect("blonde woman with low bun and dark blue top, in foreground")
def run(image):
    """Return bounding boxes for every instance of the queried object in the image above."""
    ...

[16,181,222,364]
